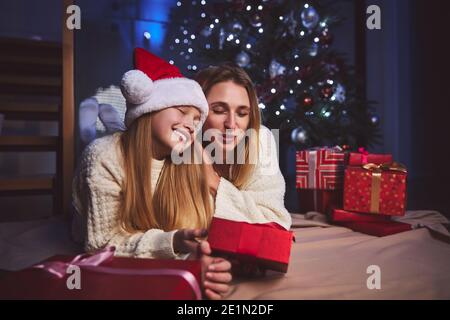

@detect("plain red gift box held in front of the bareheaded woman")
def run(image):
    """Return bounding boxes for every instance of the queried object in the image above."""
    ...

[208,218,293,272]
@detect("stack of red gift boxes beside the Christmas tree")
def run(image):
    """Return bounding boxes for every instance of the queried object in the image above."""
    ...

[296,147,411,236]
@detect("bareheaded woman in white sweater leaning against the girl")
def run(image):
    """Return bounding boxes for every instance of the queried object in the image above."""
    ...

[196,65,291,229]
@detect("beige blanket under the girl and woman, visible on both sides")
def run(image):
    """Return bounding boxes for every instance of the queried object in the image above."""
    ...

[0,211,450,299]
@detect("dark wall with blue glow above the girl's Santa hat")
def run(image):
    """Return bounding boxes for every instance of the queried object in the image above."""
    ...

[75,0,175,104]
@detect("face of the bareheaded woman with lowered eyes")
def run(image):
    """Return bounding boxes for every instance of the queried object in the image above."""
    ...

[203,81,250,153]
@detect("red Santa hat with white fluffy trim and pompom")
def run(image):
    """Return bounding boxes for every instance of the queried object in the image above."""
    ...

[120,48,208,127]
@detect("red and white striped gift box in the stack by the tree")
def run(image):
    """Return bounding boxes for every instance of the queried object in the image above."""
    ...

[296,147,345,190]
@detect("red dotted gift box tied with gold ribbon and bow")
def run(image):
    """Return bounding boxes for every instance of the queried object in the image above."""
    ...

[344,162,407,216]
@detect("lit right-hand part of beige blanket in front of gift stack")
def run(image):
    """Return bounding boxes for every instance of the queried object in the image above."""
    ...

[227,211,450,299]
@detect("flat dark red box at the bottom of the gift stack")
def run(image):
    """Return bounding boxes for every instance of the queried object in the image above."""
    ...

[338,221,412,237]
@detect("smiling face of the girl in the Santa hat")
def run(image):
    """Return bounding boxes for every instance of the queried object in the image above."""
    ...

[151,106,200,159]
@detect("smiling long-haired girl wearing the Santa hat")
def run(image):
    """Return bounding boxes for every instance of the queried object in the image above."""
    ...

[73,48,231,299]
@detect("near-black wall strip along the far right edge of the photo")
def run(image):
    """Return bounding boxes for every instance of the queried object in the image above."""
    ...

[409,0,450,215]
